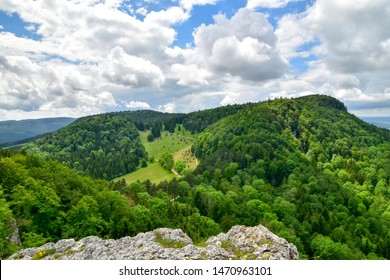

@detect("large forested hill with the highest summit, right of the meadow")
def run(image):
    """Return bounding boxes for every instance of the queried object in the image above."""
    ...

[190,96,390,259]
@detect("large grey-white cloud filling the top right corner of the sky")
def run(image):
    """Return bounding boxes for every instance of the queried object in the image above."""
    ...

[307,0,390,73]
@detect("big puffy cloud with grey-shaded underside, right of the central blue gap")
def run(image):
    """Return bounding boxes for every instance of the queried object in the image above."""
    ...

[194,9,287,81]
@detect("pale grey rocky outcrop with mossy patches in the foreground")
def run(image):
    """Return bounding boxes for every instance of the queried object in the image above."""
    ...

[9,225,299,260]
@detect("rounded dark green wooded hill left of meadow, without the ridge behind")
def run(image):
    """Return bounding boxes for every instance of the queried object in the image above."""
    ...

[23,114,147,179]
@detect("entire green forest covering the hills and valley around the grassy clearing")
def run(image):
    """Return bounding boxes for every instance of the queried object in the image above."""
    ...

[0,95,390,259]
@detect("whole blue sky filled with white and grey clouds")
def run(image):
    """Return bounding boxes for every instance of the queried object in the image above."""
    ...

[0,0,390,120]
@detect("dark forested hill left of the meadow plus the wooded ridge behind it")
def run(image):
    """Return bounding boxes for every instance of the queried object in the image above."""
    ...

[19,104,249,179]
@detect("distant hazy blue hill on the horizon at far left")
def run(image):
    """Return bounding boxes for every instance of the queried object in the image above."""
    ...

[0,118,76,144]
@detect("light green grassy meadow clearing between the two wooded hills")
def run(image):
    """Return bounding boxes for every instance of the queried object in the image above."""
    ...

[115,126,196,184]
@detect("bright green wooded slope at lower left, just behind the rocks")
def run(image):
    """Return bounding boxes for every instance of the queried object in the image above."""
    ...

[0,149,221,259]
